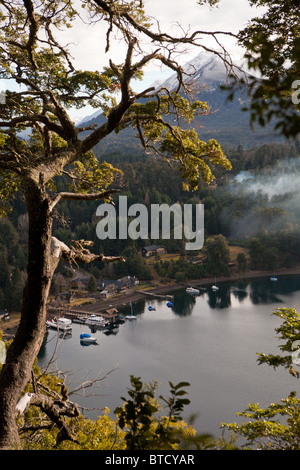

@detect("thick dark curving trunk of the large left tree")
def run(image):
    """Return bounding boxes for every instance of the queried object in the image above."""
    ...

[0,180,58,449]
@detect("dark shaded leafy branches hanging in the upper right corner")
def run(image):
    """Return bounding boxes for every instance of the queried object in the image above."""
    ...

[233,0,300,138]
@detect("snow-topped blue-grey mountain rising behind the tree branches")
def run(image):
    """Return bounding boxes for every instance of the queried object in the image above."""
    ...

[79,53,282,153]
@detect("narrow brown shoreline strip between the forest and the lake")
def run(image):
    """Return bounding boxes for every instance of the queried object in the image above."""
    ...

[0,264,300,339]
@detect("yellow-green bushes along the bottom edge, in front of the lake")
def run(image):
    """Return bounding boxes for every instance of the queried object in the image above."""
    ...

[15,362,200,450]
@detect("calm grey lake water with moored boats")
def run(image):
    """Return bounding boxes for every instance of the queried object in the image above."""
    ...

[39,275,300,437]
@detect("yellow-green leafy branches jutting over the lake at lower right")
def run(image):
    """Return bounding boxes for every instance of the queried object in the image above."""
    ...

[222,308,300,450]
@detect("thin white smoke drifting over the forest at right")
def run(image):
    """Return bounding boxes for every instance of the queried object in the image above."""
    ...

[221,157,300,239]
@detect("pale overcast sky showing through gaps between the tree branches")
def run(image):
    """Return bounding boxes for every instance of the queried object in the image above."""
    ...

[67,0,262,120]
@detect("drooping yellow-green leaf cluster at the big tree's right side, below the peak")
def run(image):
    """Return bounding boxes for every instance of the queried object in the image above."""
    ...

[130,92,231,190]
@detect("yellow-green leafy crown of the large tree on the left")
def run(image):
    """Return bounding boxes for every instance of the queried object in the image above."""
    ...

[0,0,231,217]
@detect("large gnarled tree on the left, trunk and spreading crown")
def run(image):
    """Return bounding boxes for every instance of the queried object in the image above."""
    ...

[0,0,231,448]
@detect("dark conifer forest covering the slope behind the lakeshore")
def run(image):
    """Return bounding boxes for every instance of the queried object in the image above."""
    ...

[0,137,300,309]
